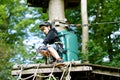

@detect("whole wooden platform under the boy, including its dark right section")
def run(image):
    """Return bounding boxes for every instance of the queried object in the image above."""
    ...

[11,61,120,80]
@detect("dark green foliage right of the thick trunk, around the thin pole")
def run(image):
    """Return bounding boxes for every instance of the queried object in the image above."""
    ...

[66,0,120,67]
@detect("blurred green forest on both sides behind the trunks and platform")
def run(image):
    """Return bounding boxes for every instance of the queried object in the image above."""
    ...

[0,0,120,80]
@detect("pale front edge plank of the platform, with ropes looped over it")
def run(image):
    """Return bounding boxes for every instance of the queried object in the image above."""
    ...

[11,66,92,75]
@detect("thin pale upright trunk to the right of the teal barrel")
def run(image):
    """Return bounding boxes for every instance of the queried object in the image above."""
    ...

[81,0,88,62]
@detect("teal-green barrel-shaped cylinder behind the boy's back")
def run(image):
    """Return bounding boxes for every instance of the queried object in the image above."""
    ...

[58,30,78,61]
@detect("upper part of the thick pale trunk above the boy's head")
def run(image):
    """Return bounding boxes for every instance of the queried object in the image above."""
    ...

[49,0,65,31]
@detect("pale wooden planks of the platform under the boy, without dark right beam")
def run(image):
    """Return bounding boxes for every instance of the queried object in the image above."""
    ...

[12,61,92,76]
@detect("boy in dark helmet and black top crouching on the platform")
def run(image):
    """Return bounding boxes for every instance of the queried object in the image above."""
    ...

[39,22,63,63]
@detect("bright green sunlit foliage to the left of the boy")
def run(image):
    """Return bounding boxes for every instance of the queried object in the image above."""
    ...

[0,0,47,80]
